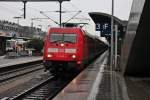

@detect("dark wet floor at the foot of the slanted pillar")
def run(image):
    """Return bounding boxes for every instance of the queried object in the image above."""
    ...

[125,77,150,100]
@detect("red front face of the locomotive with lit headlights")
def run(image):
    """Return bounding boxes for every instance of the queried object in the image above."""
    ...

[43,28,82,74]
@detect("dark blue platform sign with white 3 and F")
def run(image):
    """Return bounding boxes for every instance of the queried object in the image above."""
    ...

[96,22,111,37]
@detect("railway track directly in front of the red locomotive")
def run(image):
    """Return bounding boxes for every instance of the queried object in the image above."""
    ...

[2,76,71,100]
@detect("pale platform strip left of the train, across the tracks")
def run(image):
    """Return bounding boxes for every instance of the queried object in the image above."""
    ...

[0,56,43,68]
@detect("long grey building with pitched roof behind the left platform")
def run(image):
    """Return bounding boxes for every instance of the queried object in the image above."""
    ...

[0,20,44,56]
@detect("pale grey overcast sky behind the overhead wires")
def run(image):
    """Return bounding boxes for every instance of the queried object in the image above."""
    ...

[0,0,132,30]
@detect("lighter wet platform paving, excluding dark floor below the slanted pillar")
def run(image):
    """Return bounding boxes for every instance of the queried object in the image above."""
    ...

[53,52,129,100]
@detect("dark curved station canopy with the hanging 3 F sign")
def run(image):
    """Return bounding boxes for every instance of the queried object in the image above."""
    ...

[89,12,127,38]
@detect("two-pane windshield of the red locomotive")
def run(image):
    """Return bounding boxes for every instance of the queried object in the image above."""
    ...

[50,33,77,43]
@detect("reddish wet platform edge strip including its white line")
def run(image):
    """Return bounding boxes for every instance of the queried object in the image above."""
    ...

[53,52,108,100]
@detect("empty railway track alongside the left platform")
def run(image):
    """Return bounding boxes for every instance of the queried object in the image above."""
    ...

[0,63,44,84]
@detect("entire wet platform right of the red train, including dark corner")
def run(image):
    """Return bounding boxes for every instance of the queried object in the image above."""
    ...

[53,52,150,100]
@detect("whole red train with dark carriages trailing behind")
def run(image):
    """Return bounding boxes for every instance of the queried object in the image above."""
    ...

[43,28,107,75]
